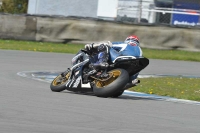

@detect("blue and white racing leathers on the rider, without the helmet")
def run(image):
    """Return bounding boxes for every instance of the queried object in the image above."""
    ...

[85,41,142,87]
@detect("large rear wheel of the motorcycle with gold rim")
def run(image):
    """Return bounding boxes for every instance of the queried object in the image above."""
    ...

[93,69,129,97]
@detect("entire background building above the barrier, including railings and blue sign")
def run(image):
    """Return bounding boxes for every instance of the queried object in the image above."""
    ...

[28,0,200,26]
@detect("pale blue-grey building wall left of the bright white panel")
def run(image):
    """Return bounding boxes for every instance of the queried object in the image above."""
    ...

[28,0,98,18]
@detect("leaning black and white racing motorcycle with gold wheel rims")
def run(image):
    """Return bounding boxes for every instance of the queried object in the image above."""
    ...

[50,49,149,97]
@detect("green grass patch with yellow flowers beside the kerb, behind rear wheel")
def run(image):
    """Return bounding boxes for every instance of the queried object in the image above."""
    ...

[129,77,200,101]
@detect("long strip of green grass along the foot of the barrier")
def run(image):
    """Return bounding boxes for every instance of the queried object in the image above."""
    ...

[0,40,200,62]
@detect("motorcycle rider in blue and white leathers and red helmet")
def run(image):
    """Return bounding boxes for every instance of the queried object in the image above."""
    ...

[85,35,142,89]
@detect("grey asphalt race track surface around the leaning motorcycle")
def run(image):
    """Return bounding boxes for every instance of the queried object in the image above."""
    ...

[0,50,200,133]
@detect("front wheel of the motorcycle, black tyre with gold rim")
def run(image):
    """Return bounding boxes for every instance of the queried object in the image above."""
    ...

[50,72,70,92]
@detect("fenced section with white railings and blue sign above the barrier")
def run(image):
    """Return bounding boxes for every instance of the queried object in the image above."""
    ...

[116,0,200,27]
